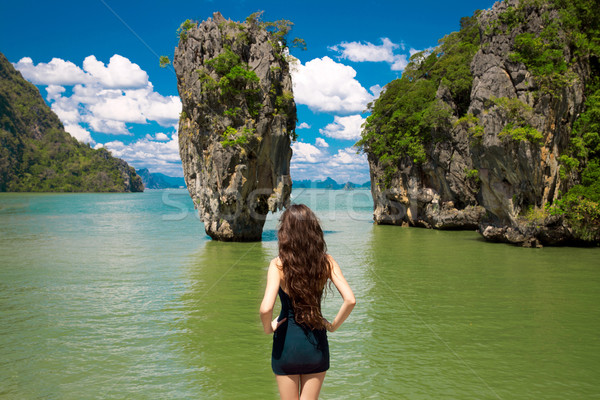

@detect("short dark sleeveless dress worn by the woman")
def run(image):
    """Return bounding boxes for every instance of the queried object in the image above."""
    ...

[271,287,329,375]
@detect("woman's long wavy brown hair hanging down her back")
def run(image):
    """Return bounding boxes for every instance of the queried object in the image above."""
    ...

[277,204,332,329]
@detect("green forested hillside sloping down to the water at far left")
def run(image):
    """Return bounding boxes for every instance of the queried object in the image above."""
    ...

[0,53,144,192]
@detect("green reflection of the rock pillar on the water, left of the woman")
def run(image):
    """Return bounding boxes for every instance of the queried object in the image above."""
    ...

[175,241,277,399]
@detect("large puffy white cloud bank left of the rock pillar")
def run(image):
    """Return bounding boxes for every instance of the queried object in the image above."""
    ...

[14,54,181,143]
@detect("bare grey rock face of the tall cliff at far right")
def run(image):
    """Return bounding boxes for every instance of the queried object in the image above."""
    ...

[469,2,590,244]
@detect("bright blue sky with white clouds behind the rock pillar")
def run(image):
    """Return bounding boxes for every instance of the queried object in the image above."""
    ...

[0,0,493,183]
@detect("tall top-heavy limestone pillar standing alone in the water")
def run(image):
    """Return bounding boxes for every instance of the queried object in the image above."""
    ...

[173,13,296,241]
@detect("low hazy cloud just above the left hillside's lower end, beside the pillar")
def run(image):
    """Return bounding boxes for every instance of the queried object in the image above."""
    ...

[95,132,182,176]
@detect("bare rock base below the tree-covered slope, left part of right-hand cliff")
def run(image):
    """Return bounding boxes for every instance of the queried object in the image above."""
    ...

[367,80,485,229]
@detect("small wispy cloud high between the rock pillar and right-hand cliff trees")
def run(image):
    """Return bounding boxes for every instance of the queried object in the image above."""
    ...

[329,38,413,71]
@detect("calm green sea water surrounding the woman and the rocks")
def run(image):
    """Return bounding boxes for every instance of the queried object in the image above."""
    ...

[0,189,600,399]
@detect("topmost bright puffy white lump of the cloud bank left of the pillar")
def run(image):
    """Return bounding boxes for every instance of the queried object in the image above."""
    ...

[83,54,148,89]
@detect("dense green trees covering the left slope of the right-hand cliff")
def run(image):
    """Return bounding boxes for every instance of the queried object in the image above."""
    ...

[357,13,479,170]
